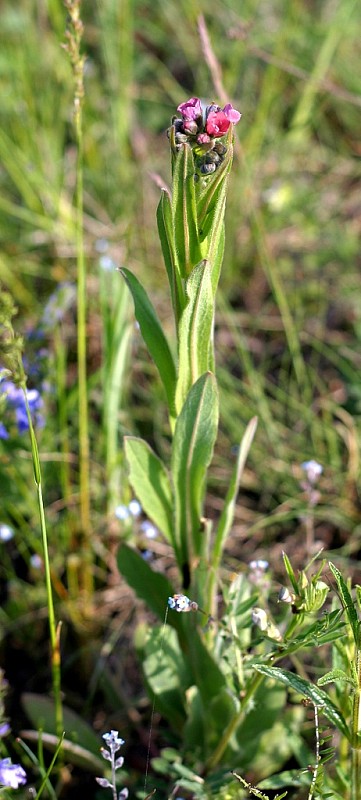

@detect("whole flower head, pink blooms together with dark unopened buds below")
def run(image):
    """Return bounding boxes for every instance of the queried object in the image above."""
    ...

[168,97,241,175]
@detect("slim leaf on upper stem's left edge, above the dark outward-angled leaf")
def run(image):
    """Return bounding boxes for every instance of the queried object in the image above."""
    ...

[157,189,186,322]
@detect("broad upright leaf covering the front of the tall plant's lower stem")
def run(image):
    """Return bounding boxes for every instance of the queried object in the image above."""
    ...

[172,372,218,568]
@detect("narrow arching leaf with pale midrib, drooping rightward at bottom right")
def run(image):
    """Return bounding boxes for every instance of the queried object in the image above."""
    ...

[253,664,350,739]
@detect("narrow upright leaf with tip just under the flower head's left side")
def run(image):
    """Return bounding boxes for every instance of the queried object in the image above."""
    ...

[172,144,202,278]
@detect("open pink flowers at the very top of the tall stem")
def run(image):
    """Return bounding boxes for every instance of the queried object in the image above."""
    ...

[177,97,241,144]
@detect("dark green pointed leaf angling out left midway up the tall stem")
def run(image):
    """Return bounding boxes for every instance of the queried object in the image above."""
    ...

[119,267,176,416]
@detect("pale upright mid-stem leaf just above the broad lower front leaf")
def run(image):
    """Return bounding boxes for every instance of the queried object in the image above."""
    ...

[175,261,214,412]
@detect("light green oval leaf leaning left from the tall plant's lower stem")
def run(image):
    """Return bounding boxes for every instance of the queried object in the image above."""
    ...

[124,436,174,544]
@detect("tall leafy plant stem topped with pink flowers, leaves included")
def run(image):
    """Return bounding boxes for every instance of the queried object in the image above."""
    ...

[121,98,245,611]
